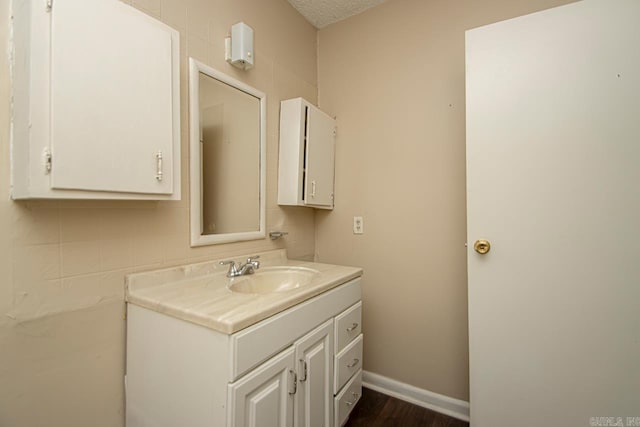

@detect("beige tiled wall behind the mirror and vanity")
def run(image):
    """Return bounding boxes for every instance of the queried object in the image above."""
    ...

[0,0,317,427]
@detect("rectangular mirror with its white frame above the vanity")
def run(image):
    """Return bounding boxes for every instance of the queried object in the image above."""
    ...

[189,58,267,246]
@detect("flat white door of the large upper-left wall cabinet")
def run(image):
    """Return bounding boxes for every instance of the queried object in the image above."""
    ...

[51,0,176,194]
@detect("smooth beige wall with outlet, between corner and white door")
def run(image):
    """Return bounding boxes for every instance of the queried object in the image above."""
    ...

[316,0,570,400]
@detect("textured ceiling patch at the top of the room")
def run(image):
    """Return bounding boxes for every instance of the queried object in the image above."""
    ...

[288,0,386,28]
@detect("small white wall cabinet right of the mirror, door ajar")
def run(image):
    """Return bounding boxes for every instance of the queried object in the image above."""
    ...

[278,98,336,209]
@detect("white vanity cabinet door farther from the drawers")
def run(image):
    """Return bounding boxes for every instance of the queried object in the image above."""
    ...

[227,347,296,427]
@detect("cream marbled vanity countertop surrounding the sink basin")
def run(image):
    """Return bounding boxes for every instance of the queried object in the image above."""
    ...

[126,249,362,334]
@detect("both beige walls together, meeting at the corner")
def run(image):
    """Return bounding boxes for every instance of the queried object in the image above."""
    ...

[0,0,584,426]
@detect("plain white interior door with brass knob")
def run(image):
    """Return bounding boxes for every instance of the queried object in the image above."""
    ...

[467,0,640,427]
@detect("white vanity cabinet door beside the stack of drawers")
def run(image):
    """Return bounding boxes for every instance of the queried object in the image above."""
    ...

[294,319,333,427]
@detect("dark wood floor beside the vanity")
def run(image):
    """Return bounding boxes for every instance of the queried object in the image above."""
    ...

[345,387,469,427]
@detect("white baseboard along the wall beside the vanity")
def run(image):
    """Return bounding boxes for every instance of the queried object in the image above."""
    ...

[362,371,469,422]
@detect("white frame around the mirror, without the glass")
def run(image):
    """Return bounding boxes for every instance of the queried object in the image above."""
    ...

[189,57,267,247]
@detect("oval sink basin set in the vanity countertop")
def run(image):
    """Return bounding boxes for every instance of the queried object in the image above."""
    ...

[229,266,319,294]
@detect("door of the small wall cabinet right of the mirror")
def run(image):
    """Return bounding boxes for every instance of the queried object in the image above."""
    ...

[305,108,336,208]
